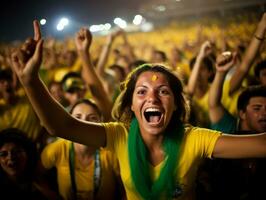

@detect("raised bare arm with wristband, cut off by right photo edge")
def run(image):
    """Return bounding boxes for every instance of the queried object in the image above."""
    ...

[229,13,266,95]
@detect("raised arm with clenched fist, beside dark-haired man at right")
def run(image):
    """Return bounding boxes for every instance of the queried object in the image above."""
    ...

[209,52,236,124]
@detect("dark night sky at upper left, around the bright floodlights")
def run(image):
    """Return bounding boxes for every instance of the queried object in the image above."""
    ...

[0,0,143,41]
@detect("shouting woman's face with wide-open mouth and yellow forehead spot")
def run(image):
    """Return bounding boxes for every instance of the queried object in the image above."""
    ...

[131,71,176,135]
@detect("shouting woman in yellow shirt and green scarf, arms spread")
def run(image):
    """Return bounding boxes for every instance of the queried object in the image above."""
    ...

[12,21,266,199]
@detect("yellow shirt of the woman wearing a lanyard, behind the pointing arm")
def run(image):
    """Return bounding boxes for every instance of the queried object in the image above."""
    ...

[41,139,119,200]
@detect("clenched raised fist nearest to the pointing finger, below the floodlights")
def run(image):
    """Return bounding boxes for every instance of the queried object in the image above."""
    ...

[75,28,92,52]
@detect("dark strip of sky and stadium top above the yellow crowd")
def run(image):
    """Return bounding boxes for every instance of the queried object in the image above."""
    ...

[0,0,266,42]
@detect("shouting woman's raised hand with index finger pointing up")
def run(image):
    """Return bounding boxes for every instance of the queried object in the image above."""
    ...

[11,20,43,84]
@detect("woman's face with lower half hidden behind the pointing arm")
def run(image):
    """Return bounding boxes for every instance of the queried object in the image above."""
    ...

[72,103,101,122]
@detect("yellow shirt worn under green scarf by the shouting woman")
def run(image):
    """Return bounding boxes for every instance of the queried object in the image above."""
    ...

[103,122,221,200]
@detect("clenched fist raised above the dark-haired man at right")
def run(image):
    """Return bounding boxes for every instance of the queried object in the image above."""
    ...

[215,51,236,72]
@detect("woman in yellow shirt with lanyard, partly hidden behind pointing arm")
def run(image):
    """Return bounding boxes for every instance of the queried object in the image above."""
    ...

[41,99,123,200]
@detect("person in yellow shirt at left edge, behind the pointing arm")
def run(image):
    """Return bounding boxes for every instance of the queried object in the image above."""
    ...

[0,69,43,143]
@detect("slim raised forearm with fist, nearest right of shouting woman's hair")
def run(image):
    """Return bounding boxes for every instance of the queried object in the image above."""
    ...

[186,41,212,96]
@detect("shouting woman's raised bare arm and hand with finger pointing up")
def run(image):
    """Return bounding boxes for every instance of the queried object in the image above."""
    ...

[12,20,106,148]
